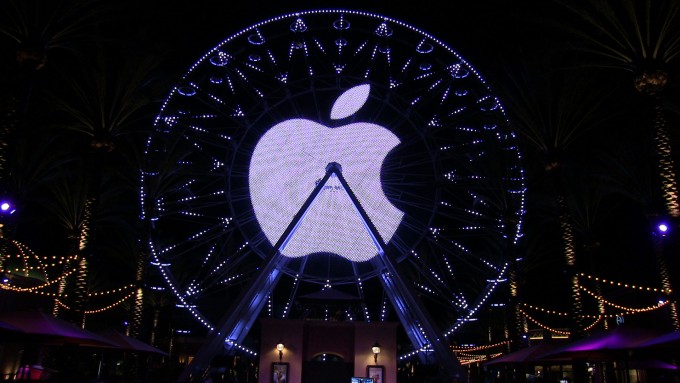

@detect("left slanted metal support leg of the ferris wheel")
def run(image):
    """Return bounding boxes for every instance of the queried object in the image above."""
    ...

[178,167,336,382]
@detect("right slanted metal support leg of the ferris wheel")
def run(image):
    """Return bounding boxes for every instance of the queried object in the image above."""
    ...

[335,168,467,382]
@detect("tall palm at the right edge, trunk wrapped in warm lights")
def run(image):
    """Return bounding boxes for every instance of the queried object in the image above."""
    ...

[560,0,680,329]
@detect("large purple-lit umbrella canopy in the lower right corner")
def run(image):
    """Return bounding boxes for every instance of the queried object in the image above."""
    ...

[541,326,659,361]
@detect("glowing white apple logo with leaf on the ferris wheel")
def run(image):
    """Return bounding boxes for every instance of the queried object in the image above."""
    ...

[248,84,404,262]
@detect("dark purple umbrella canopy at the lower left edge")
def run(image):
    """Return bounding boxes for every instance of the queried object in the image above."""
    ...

[0,311,117,348]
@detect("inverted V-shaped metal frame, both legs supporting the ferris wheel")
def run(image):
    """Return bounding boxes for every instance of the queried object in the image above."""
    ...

[178,163,465,382]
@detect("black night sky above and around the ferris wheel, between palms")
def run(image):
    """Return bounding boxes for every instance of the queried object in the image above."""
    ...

[0,0,680,348]
